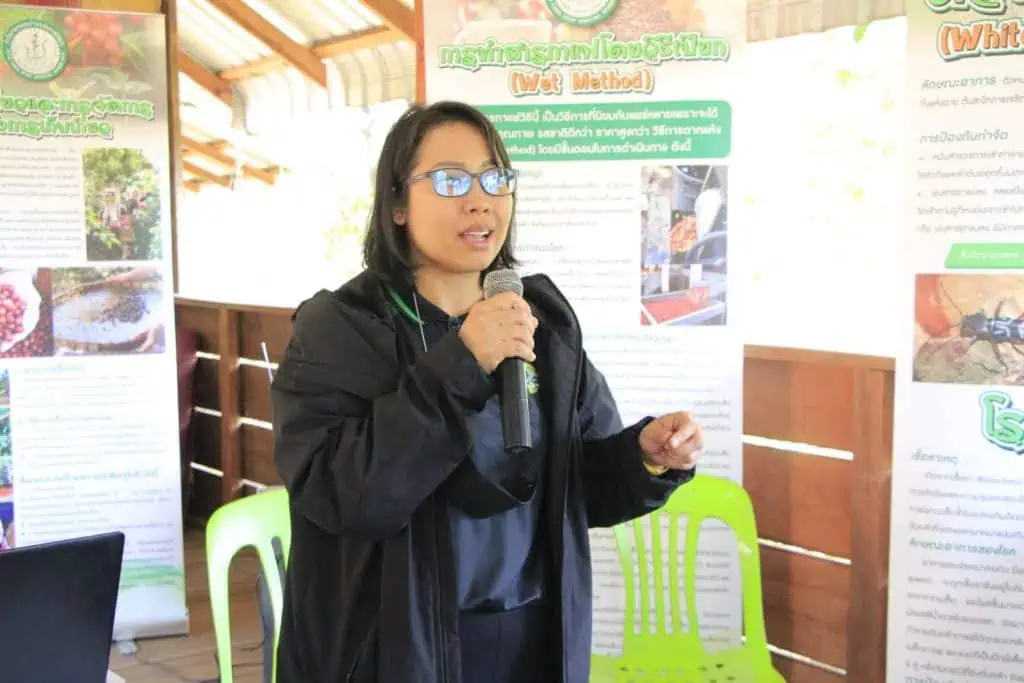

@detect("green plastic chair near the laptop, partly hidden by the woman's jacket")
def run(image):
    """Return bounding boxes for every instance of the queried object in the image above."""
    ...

[206,488,292,683]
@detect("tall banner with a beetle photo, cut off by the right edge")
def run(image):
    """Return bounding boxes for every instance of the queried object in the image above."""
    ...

[887,0,1024,683]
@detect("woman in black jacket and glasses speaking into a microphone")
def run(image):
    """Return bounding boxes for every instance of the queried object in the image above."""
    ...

[272,102,702,683]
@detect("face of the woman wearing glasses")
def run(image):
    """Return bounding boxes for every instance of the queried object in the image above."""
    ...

[395,122,515,274]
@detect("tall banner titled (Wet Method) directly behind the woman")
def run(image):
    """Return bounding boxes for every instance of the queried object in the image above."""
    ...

[424,0,746,653]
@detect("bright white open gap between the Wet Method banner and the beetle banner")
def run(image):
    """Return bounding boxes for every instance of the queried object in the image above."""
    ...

[733,17,906,355]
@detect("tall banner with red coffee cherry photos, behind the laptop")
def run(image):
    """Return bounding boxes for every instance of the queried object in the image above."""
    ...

[0,5,187,639]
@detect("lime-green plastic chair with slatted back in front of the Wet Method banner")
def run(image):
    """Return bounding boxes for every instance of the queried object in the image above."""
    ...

[591,474,785,683]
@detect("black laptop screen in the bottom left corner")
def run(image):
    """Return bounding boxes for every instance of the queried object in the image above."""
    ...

[0,531,125,683]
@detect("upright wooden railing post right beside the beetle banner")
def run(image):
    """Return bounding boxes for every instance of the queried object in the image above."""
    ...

[846,368,894,683]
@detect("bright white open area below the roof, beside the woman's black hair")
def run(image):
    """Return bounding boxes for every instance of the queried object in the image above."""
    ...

[177,101,408,306]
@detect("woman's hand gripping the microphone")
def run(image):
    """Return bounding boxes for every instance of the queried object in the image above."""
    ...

[459,292,537,375]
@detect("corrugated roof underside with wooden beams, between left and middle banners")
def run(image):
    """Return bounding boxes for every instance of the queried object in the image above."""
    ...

[177,0,416,187]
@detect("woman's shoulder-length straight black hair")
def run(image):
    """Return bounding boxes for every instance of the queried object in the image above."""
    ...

[362,100,518,283]
